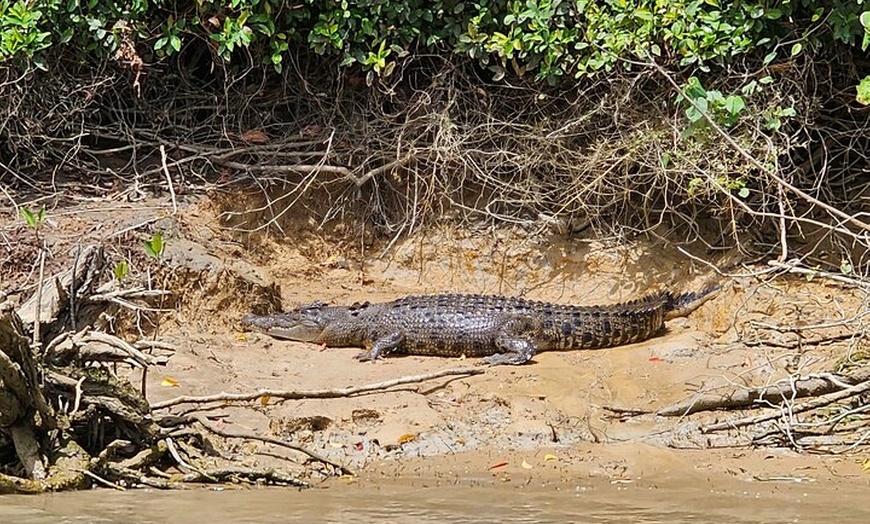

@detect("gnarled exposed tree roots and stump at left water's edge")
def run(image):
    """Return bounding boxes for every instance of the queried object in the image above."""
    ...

[0,247,307,493]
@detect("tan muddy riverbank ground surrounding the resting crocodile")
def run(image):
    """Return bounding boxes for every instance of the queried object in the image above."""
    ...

[0,194,870,490]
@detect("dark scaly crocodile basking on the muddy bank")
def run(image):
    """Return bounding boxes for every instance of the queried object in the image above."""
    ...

[242,286,718,364]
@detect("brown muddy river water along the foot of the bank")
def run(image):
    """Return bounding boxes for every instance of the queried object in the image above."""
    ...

[0,479,870,524]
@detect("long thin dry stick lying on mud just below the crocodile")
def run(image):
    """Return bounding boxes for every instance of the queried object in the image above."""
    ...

[151,368,484,410]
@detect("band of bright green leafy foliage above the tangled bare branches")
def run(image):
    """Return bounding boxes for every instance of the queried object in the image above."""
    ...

[0,0,870,84]
